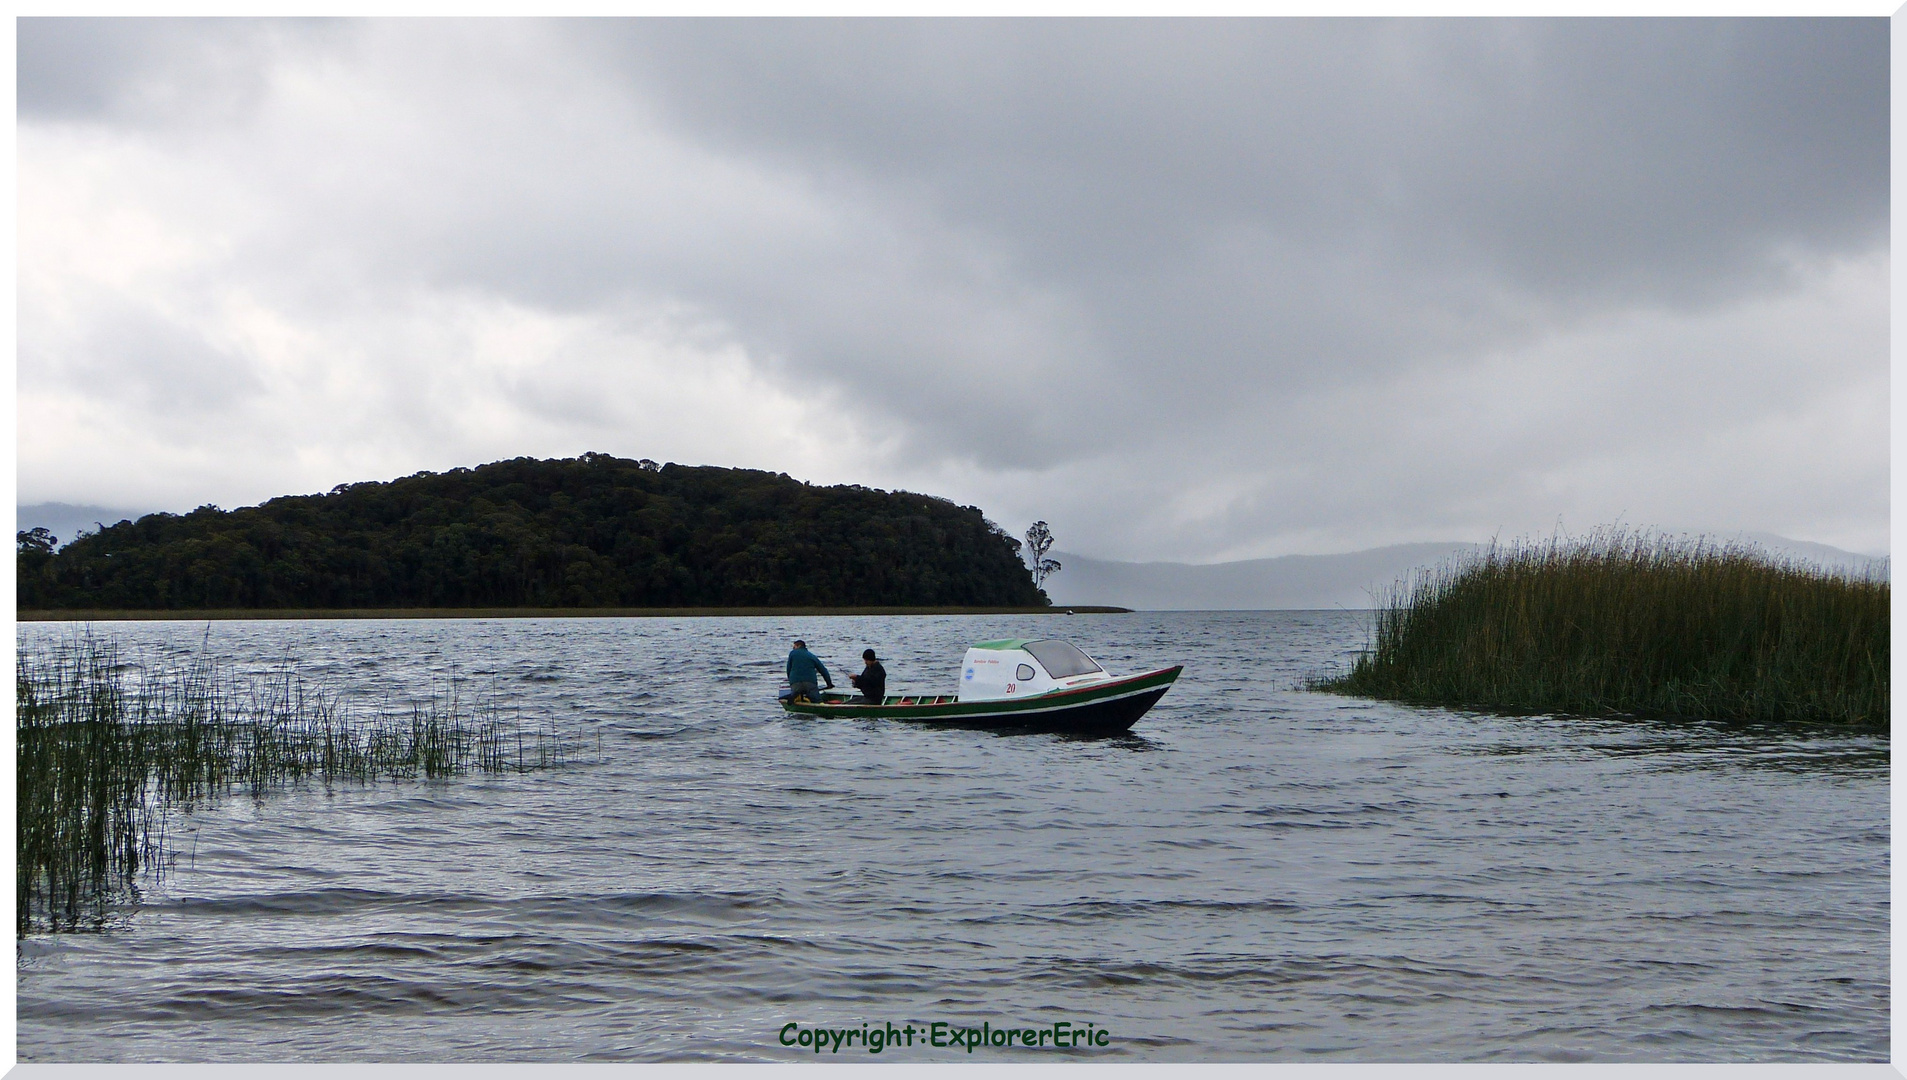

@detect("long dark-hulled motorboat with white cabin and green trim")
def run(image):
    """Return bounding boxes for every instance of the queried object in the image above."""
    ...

[782,637,1184,735]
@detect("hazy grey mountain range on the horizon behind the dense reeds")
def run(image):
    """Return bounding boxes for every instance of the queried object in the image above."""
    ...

[1047,532,1888,611]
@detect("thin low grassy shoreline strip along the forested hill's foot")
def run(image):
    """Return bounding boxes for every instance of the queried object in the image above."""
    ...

[15,605,1133,622]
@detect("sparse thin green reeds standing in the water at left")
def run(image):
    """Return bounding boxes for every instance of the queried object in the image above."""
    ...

[15,637,574,933]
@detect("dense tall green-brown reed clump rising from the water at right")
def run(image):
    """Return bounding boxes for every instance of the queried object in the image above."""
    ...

[1310,530,1890,729]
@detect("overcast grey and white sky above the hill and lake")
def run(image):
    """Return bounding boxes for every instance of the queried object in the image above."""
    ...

[17,19,1888,561]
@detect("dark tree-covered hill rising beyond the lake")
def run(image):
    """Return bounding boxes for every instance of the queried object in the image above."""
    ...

[17,454,1047,609]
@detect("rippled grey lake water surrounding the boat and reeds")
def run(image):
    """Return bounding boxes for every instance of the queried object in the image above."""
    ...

[19,613,1888,1061]
